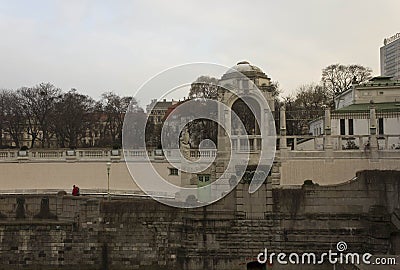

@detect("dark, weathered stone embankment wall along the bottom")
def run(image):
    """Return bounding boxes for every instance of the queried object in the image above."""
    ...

[0,171,400,270]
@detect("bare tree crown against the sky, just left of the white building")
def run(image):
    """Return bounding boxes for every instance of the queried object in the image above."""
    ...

[321,64,372,95]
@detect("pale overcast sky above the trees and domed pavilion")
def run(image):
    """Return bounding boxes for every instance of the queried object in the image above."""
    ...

[0,0,400,106]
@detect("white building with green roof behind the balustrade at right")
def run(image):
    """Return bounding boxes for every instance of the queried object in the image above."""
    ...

[309,77,400,149]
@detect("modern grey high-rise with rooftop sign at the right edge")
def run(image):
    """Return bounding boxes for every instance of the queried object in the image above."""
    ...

[380,33,400,80]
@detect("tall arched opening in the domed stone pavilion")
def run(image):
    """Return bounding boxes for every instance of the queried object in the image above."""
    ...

[231,97,262,151]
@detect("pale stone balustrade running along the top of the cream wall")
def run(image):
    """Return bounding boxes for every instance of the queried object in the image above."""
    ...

[0,135,400,162]
